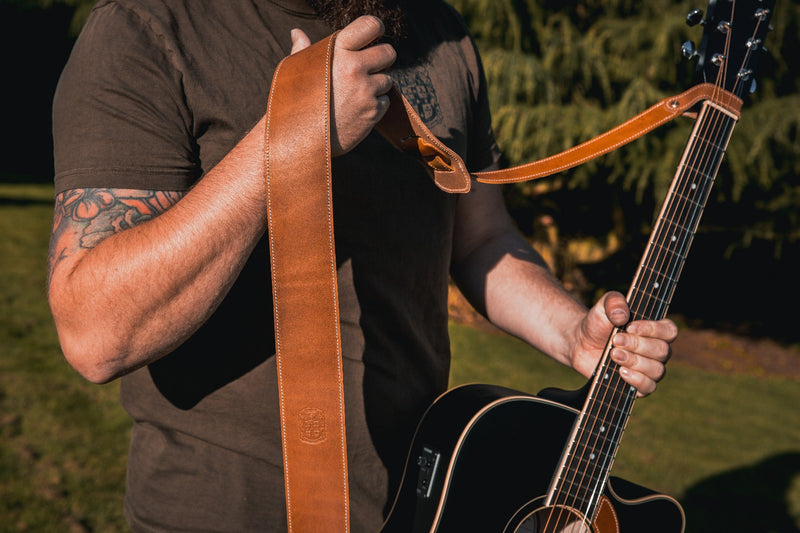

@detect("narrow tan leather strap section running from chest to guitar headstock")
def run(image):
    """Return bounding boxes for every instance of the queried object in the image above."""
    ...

[376,83,742,192]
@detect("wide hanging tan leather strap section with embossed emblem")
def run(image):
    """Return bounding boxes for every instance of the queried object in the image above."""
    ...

[265,32,349,533]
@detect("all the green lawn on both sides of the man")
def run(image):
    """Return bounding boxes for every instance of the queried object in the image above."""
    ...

[0,184,800,533]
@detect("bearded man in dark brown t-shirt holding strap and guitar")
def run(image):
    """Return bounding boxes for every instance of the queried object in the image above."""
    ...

[49,0,677,531]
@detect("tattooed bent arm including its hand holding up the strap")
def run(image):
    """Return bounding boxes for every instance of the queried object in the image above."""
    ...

[49,17,395,383]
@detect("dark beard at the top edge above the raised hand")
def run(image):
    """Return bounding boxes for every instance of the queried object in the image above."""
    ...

[308,0,406,43]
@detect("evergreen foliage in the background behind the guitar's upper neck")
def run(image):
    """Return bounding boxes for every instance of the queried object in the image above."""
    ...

[451,0,800,270]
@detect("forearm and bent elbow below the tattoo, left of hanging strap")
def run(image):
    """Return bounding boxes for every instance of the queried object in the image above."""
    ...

[50,117,266,382]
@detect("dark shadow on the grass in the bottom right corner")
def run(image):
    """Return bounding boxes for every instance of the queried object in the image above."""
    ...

[681,452,800,533]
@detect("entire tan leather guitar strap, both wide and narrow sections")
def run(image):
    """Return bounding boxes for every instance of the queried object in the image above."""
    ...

[265,34,741,533]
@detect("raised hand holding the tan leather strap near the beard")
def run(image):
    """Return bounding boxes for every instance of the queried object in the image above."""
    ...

[292,15,397,156]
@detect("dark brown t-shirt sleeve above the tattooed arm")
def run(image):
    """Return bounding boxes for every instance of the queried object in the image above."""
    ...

[53,3,199,193]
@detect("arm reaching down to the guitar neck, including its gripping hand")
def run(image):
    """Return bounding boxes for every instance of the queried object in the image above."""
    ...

[452,183,678,395]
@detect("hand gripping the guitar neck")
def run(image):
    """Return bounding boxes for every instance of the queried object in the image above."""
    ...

[572,292,678,397]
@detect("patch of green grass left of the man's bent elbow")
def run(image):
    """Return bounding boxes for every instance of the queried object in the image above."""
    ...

[0,184,130,532]
